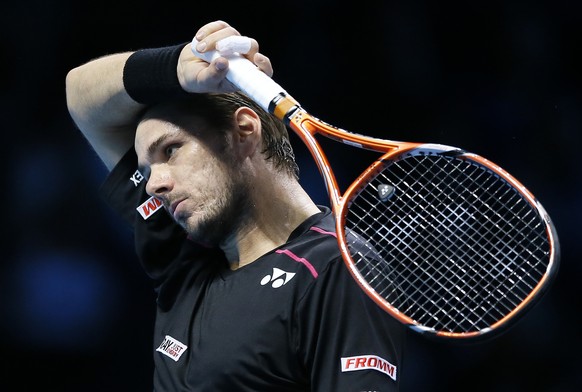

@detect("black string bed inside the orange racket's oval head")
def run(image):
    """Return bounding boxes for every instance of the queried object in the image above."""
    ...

[345,155,549,333]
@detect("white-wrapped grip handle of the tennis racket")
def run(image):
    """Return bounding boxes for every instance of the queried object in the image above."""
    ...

[191,38,288,111]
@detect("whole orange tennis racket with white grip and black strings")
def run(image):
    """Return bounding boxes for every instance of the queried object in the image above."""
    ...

[192,36,559,339]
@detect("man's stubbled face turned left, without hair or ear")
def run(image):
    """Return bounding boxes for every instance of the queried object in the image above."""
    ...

[135,114,248,245]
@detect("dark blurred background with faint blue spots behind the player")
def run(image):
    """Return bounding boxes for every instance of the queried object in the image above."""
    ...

[0,0,582,392]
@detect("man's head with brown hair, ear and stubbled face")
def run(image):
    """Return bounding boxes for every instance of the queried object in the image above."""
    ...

[135,93,298,244]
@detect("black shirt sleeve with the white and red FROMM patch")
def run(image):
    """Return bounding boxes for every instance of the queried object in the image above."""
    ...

[299,258,407,392]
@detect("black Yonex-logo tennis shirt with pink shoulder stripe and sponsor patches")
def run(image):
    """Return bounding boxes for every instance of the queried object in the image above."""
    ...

[102,149,406,392]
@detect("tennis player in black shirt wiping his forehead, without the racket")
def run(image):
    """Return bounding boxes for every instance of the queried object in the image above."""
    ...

[66,21,406,392]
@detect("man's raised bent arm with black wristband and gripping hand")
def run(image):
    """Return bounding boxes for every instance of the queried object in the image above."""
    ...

[66,21,273,169]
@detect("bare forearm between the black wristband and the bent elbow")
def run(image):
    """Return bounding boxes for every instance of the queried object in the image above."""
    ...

[66,52,144,169]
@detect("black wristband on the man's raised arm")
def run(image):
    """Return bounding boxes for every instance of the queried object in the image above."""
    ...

[123,44,188,105]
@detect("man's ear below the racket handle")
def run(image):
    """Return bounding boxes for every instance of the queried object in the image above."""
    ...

[234,106,262,159]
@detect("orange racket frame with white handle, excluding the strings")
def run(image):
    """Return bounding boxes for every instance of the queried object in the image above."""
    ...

[192,40,559,339]
